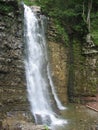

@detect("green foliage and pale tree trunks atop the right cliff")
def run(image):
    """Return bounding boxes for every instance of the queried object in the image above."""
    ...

[33,0,98,44]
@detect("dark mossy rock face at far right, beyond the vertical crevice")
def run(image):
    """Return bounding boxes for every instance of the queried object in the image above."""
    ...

[73,43,98,103]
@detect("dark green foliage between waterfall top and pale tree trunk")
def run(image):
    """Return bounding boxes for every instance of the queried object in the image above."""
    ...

[38,0,86,41]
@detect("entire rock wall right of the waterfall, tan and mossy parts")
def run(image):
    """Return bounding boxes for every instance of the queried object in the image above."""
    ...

[48,19,98,104]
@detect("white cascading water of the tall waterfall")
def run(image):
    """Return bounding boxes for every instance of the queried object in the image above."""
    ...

[24,5,65,126]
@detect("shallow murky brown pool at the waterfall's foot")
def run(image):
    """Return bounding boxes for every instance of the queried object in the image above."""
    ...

[54,104,98,130]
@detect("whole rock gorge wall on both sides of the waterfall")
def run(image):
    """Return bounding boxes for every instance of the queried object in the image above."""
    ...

[0,0,98,122]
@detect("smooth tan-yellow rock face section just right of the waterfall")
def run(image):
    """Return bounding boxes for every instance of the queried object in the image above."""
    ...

[48,42,68,104]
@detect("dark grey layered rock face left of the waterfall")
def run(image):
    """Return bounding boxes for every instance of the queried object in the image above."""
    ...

[0,0,27,117]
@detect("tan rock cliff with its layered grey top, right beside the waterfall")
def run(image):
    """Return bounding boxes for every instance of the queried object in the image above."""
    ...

[47,19,68,104]
